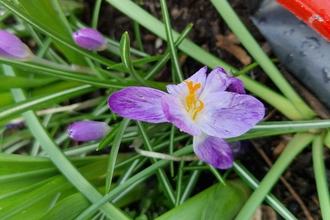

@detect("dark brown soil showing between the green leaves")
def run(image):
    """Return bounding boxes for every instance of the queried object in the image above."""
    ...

[81,0,329,219]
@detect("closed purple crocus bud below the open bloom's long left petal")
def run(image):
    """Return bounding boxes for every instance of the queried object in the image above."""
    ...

[68,121,111,141]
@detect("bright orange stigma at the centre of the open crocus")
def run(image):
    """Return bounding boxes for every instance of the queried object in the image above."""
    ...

[184,80,204,120]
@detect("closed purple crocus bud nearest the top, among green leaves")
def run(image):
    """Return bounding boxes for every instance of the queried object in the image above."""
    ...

[72,28,107,51]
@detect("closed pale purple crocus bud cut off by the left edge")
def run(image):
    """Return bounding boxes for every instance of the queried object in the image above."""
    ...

[0,30,34,60]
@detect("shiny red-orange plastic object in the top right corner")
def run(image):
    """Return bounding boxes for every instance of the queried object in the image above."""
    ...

[277,0,330,41]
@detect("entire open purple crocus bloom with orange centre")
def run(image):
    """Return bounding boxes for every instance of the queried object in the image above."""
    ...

[108,67,265,169]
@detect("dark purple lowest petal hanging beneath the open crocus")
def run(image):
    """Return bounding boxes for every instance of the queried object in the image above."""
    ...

[193,134,233,169]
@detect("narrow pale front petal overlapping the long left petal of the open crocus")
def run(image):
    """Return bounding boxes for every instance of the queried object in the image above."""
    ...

[162,94,201,135]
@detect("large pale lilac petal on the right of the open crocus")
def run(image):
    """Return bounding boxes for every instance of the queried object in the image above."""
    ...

[197,92,265,138]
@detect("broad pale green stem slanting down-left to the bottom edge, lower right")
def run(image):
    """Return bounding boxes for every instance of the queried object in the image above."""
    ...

[236,133,314,220]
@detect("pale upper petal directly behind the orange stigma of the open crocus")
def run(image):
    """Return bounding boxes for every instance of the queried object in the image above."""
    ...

[166,66,207,100]
